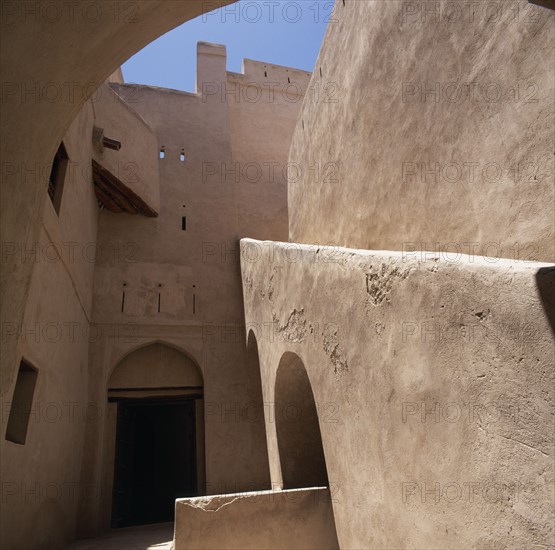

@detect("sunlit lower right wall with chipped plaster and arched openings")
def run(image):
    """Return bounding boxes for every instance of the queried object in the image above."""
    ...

[241,239,555,550]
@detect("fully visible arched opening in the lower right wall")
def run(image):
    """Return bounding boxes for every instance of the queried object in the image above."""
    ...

[274,352,328,489]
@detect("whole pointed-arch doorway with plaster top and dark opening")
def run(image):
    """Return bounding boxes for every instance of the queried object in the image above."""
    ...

[108,343,204,527]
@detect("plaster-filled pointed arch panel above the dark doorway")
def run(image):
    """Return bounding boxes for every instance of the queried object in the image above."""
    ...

[108,342,203,389]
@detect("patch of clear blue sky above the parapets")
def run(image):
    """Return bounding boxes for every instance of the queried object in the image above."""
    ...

[123,0,334,92]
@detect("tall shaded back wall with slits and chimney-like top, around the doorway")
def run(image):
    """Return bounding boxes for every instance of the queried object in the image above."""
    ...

[77,43,308,533]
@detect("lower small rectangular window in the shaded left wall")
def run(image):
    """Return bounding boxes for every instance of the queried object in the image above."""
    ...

[6,361,38,445]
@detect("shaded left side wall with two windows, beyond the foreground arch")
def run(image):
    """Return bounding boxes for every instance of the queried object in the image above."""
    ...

[2,98,98,548]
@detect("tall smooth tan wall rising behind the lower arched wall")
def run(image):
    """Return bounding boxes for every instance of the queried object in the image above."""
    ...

[288,0,555,261]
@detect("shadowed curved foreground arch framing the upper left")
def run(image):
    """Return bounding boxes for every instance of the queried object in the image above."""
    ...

[0,0,235,436]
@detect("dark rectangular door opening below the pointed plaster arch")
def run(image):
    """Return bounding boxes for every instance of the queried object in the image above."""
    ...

[112,398,197,527]
